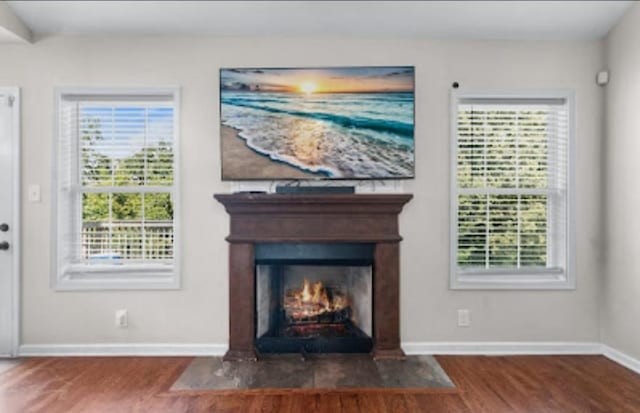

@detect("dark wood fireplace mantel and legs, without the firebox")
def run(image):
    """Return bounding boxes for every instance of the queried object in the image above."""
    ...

[214,193,412,360]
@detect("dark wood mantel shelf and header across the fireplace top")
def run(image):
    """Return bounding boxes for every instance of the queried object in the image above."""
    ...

[215,193,412,243]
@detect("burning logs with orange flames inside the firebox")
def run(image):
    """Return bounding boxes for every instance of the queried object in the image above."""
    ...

[284,278,348,320]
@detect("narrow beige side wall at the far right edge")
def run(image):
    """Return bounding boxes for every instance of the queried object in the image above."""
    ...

[601,4,640,359]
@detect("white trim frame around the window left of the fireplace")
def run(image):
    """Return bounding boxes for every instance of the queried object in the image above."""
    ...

[50,86,182,291]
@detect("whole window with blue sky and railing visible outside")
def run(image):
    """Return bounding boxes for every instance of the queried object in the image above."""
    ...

[53,89,179,289]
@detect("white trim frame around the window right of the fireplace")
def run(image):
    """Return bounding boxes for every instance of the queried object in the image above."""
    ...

[449,89,576,290]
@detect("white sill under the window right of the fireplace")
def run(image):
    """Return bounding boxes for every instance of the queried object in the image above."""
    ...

[449,271,576,290]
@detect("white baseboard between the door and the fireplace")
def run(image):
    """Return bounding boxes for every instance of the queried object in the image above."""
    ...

[18,343,227,357]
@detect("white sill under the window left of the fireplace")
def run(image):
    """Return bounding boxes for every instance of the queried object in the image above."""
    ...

[52,269,180,291]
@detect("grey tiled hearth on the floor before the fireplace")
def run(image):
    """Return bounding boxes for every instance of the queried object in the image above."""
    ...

[171,354,454,391]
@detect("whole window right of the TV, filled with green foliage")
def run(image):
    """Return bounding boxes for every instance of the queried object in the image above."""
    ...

[451,93,575,289]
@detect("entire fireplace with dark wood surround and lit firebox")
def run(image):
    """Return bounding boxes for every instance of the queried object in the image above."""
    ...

[214,193,412,360]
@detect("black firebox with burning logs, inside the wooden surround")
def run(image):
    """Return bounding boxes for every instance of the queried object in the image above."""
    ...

[255,243,373,354]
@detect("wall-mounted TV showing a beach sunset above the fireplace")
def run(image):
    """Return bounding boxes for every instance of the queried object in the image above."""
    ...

[220,66,415,180]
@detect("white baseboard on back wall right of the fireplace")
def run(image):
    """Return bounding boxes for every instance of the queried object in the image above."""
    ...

[402,341,602,355]
